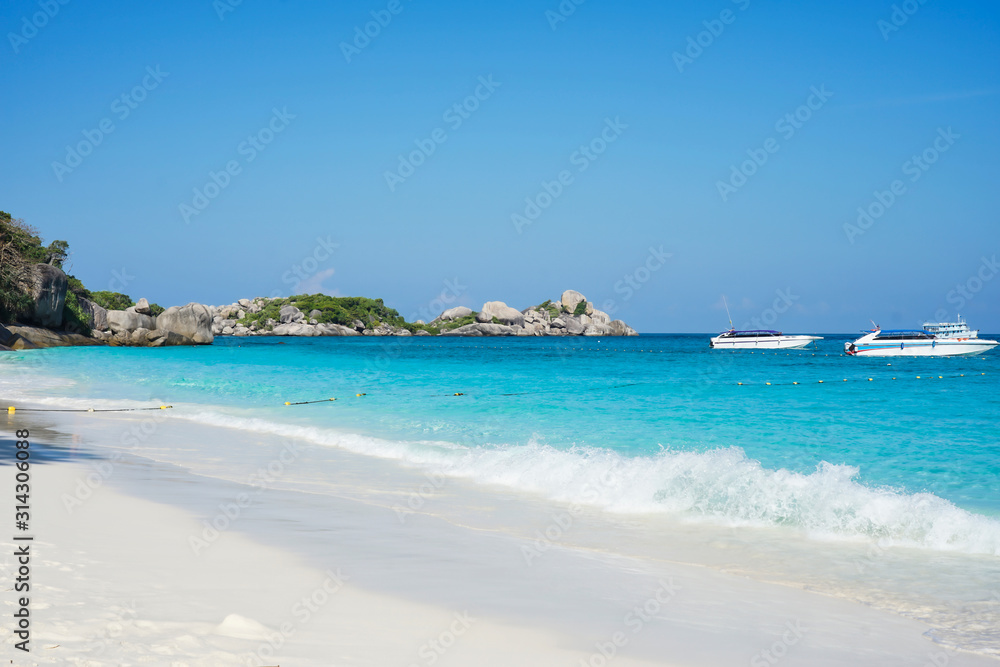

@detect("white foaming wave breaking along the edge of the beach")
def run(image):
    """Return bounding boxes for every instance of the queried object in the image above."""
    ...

[172,410,1000,555]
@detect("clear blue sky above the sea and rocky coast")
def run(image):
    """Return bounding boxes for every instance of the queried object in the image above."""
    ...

[0,0,1000,332]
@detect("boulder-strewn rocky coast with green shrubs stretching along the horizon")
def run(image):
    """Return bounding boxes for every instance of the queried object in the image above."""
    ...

[0,211,637,350]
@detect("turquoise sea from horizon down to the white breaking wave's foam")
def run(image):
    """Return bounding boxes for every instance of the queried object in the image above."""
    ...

[0,335,1000,556]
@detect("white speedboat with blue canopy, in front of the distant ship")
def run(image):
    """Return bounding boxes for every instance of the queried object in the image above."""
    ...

[844,323,1000,357]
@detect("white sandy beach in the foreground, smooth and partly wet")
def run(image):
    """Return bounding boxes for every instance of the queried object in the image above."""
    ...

[0,415,997,667]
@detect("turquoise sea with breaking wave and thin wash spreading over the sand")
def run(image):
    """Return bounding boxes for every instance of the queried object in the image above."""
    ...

[0,335,1000,654]
